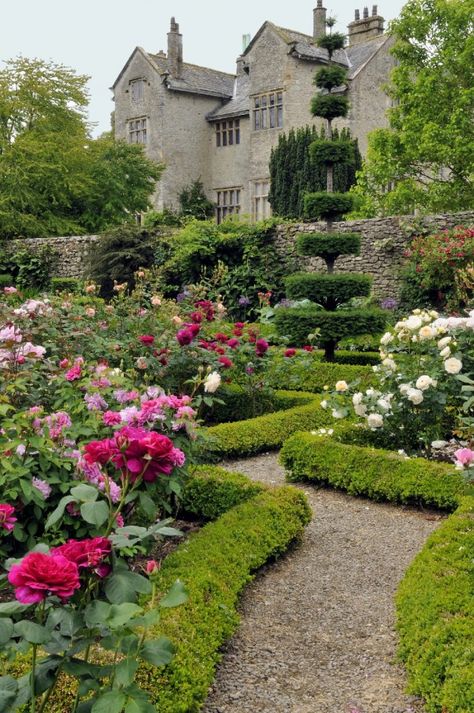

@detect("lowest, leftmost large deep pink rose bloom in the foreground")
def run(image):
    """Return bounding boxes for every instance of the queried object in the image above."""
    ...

[8,552,80,604]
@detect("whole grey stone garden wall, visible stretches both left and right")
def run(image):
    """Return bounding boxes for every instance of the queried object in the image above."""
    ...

[10,211,474,298]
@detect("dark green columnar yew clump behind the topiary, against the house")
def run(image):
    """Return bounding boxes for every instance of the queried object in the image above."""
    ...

[268,126,362,219]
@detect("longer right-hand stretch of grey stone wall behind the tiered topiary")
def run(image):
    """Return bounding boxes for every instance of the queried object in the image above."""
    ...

[276,211,474,299]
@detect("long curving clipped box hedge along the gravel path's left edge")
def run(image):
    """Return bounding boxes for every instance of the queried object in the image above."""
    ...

[139,487,311,713]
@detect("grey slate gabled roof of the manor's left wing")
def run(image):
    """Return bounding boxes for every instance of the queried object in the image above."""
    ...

[112,47,235,99]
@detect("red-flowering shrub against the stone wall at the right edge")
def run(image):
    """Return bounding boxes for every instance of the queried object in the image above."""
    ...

[405,226,474,310]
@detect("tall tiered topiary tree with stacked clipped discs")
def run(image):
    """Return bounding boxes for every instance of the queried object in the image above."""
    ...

[276,20,385,361]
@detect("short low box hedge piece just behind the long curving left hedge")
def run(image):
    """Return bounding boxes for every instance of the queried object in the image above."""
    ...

[180,465,265,520]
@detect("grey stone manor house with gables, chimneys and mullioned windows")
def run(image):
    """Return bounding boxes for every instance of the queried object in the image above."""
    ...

[112,0,394,221]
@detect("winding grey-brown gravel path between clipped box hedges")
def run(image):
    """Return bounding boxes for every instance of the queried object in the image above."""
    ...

[204,454,441,713]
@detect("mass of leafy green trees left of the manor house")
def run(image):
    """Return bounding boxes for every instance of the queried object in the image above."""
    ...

[0,57,162,238]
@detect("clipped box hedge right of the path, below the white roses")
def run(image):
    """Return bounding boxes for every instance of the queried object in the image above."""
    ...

[280,433,466,510]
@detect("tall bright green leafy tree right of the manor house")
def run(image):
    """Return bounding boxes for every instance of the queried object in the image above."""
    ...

[355,0,474,217]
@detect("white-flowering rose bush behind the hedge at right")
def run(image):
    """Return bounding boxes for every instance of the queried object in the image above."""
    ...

[322,310,474,450]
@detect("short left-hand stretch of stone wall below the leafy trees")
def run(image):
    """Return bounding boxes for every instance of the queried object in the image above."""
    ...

[7,235,98,277]
